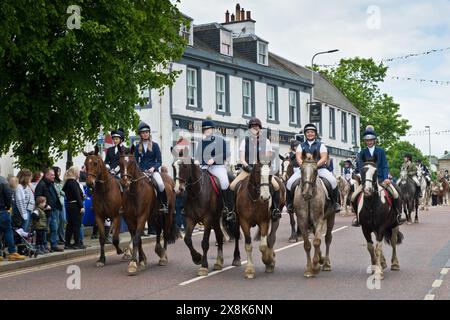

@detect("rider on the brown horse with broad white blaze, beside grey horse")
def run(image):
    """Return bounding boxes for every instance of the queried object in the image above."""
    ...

[230,118,281,219]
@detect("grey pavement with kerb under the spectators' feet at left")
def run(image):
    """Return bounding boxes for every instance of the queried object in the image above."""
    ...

[0,232,156,274]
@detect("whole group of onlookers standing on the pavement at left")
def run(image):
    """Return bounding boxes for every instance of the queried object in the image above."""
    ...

[0,166,86,261]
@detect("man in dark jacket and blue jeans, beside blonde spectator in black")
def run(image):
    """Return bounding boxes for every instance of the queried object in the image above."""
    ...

[34,169,64,252]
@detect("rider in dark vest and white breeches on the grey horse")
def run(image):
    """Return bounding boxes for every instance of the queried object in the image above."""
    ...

[286,123,341,212]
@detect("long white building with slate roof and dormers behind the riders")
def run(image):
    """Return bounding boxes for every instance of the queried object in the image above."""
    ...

[2,6,360,178]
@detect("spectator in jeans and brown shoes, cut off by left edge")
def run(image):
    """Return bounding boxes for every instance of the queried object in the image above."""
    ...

[0,172,25,261]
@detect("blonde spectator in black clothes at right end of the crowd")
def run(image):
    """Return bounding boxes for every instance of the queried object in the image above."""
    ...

[63,167,86,249]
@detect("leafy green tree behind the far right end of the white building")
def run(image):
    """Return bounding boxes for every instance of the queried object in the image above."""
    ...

[319,58,411,149]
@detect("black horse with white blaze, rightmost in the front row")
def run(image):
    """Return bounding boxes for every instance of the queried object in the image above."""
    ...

[354,162,403,280]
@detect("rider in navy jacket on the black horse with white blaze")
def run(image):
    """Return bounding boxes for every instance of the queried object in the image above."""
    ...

[351,125,405,227]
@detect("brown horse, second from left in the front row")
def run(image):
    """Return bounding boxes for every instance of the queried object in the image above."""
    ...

[119,145,160,275]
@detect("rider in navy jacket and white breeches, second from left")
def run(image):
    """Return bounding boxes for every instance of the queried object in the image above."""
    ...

[134,122,168,214]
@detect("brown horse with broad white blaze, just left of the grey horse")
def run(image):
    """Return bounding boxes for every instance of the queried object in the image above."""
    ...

[236,163,284,279]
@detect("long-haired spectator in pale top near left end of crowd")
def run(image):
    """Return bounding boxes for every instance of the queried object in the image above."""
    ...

[16,169,35,232]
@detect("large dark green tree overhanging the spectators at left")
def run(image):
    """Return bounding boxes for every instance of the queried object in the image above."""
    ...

[0,0,188,169]
